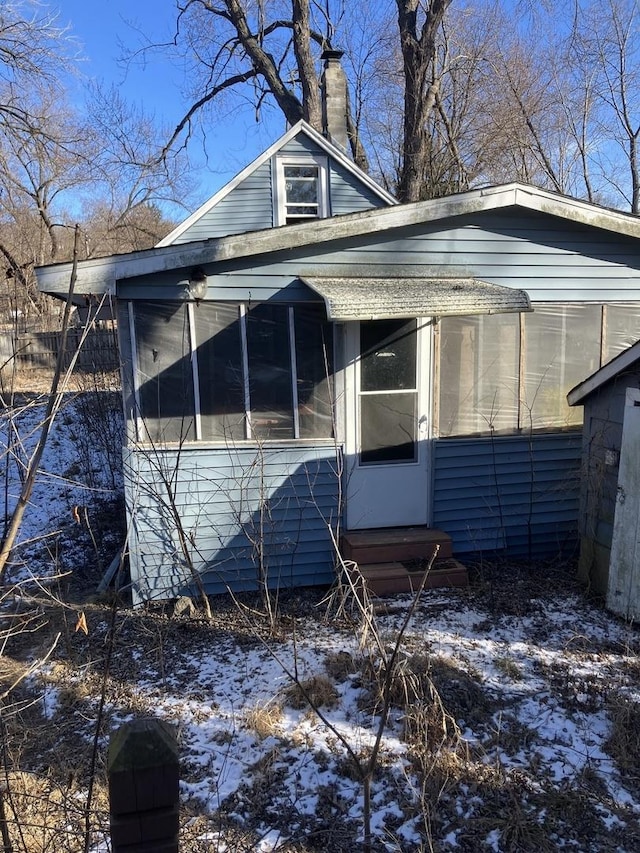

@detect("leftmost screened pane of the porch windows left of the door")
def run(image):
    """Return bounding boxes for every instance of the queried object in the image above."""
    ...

[134,302,195,442]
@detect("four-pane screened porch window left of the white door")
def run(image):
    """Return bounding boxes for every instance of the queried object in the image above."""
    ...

[131,302,333,443]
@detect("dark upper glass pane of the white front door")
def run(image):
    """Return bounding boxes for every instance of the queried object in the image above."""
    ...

[360,320,416,391]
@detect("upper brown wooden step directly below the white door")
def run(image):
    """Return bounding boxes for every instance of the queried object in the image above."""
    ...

[340,527,452,565]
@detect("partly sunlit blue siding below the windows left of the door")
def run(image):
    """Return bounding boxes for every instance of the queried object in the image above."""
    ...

[125,446,338,604]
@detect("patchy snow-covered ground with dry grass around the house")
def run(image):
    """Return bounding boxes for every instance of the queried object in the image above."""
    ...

[5,394,640,853]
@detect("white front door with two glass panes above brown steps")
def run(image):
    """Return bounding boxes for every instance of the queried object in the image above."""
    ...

[345,319,431,530]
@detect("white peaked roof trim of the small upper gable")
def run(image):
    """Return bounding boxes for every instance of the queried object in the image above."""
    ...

[156,120,398,248]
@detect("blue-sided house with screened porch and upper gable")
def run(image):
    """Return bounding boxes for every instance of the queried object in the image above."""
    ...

[37,65,640,603]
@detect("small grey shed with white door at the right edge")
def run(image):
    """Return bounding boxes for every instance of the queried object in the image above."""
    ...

[567,340,640,619]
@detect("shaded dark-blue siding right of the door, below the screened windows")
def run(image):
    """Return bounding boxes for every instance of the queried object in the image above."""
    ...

[433,433,581,558]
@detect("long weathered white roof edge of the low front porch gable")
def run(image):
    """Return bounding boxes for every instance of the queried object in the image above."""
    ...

[36,183,640,294]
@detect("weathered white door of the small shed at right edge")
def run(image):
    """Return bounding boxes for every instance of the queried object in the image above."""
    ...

[607,388,640,620]
